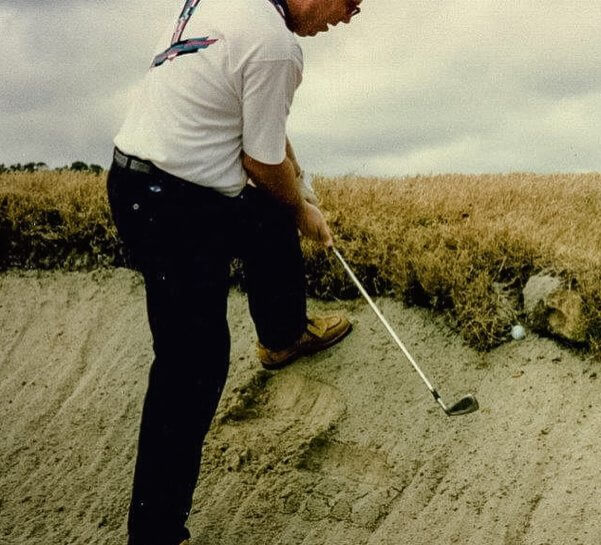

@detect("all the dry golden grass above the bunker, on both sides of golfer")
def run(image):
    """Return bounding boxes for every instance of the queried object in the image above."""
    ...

[0,172,601,349]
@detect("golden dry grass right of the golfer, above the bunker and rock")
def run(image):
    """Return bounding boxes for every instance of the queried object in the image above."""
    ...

[308,174,601,349]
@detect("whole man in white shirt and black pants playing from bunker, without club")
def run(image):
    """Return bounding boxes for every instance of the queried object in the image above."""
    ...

[108,0,360,545]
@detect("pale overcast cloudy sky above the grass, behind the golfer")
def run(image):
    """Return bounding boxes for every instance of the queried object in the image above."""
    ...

[0,0,601,177]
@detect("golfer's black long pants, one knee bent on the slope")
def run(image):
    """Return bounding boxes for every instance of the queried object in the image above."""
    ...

[108,160,306,545]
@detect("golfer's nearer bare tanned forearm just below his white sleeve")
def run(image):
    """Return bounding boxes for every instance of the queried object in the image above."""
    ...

[242,155,303,216]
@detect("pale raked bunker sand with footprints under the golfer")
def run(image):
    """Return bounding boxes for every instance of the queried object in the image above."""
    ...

[0,270,601,545]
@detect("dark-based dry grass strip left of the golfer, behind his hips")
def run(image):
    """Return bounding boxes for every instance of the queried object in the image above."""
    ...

[0,171,123,270]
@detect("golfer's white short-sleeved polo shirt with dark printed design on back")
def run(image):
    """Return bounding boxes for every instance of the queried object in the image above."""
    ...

[115,0,303,196]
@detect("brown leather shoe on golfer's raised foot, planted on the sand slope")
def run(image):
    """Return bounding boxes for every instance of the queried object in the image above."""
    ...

[257,312,352,370]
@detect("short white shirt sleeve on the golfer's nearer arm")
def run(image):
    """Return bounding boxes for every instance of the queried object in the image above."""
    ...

[242,58,302,165]
